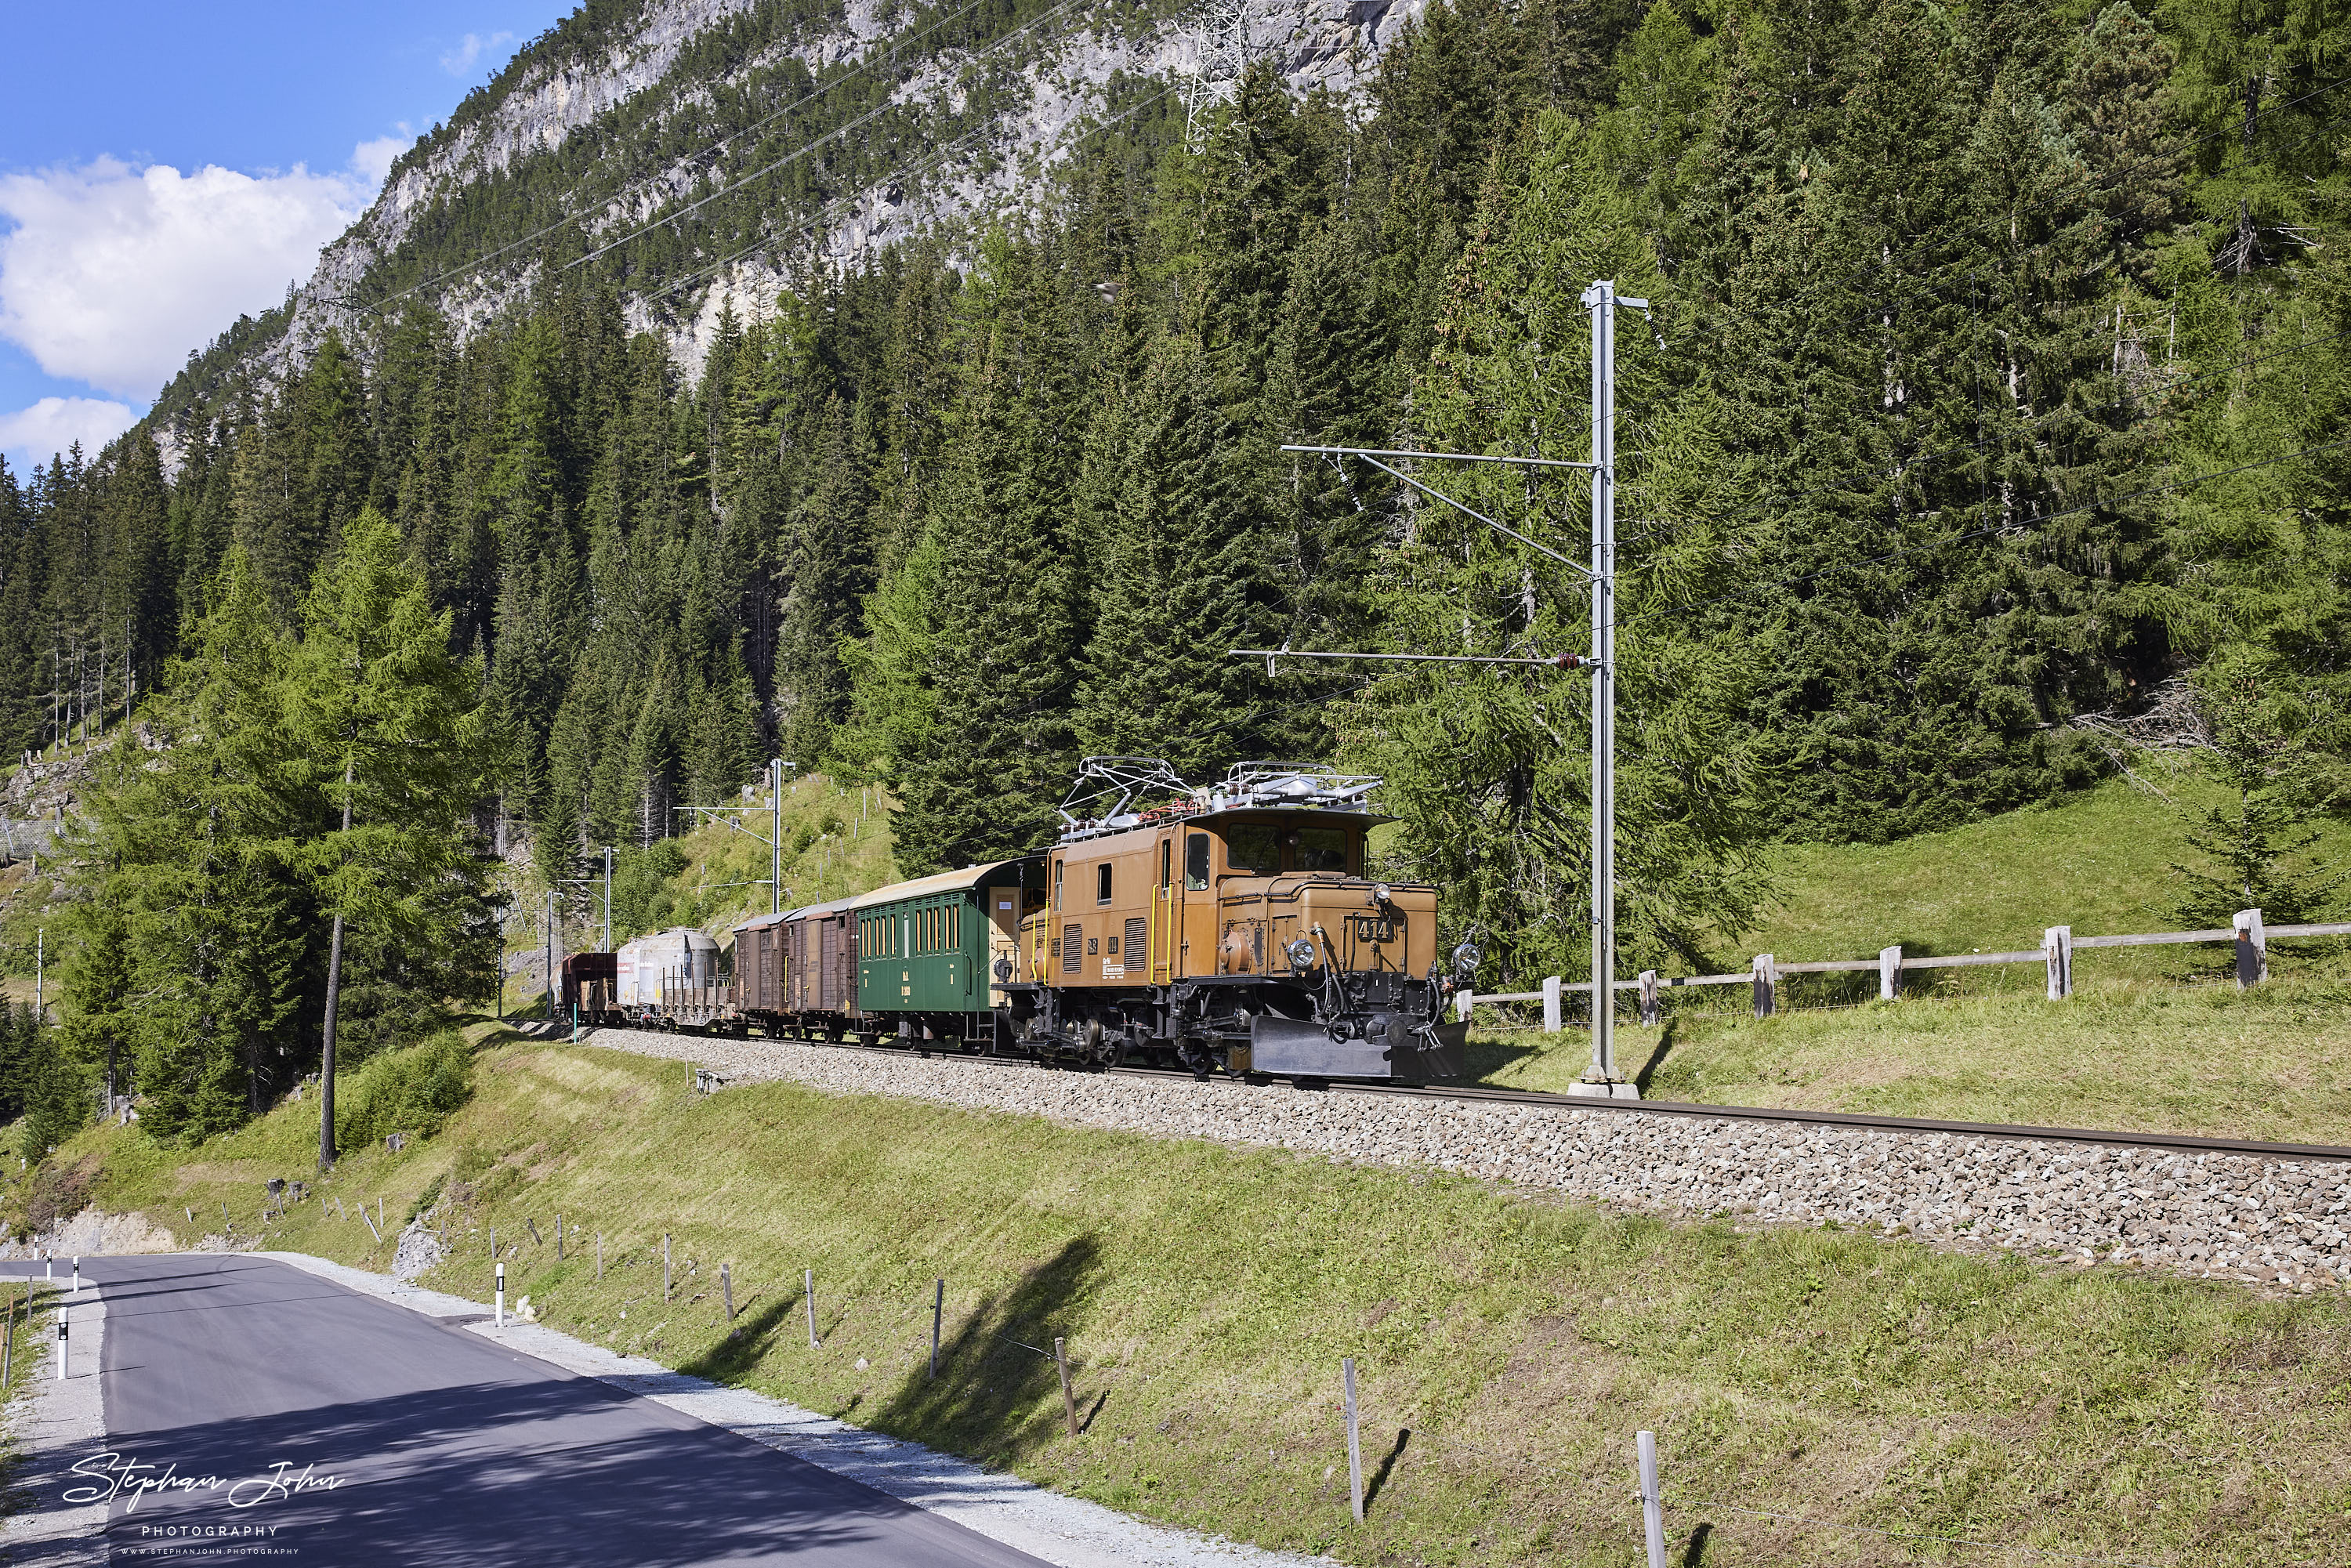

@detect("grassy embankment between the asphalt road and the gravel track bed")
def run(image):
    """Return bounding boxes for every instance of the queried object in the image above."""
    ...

[50,1037,2351,1568]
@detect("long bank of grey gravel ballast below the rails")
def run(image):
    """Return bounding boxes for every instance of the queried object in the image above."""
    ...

[569,1030,2351,1291]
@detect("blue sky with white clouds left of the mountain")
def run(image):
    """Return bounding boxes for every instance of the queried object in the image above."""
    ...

[0,0,574,473]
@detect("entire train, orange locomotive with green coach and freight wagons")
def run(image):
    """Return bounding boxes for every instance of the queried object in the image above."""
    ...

[560,757,1481,1081]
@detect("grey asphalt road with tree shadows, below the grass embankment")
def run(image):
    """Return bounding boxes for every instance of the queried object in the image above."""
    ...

[0,1255,1037,1568]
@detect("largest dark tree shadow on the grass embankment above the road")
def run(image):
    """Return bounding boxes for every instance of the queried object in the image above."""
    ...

[868,1234,1110,1465]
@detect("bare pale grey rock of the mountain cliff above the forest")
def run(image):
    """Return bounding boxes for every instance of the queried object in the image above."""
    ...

[270,0,1425,371]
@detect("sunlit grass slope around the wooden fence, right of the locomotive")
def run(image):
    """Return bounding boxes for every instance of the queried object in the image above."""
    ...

[1472,785,2351,1143]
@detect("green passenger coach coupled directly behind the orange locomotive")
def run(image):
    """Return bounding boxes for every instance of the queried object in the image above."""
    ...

[851,856,1039,1048]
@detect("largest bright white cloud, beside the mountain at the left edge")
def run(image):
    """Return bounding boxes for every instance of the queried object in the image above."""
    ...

[0,139,400,397]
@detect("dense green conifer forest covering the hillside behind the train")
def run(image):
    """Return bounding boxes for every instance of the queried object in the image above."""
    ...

[0,0,2351,1133]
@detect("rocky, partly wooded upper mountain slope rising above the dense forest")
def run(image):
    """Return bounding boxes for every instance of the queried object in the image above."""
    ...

[160,0,1425,414]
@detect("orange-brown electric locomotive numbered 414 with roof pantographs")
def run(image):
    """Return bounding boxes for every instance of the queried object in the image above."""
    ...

[994,757,1467,1079]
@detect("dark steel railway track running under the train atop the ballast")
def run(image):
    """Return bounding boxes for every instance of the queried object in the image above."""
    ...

[630,1039,2351,1161]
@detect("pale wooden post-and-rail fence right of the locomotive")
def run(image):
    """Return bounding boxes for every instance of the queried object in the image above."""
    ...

[1453,910,2351,1034]
